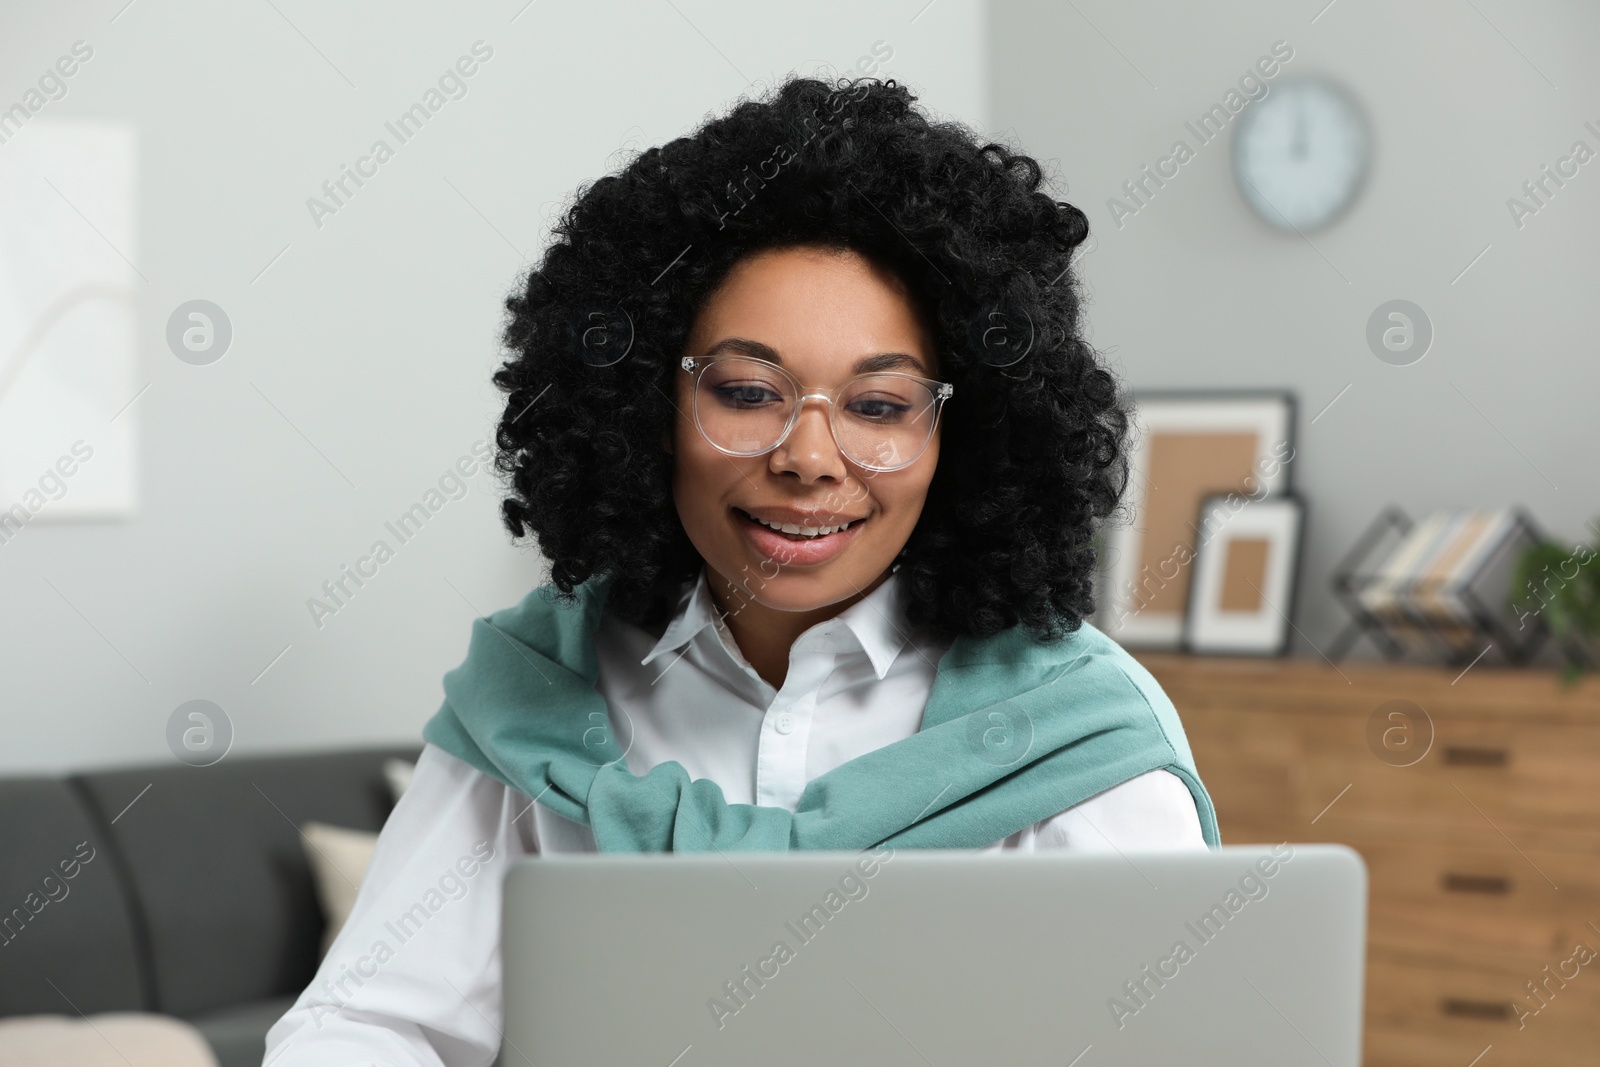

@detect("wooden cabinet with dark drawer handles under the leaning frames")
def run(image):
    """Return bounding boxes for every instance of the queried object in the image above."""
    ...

[1136,653,1600,1067]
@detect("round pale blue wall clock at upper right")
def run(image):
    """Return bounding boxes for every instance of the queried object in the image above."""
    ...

[1234,78,1371,232]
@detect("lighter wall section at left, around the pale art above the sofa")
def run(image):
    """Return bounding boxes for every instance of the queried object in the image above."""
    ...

[0,0,987,771]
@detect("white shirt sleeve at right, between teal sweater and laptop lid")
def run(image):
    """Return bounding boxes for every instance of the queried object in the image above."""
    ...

[1034,769,1206,851]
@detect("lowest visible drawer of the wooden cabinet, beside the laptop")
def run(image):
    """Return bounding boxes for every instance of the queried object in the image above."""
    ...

[1365,939,1600,1067]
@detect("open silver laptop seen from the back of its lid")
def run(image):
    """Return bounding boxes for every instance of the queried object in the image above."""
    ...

[499,843,1366,1067]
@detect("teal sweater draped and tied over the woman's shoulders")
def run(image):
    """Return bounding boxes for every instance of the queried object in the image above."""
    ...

[422,574,1221,853]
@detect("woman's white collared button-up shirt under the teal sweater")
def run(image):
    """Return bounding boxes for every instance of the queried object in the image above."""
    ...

[264,568,1206,1067]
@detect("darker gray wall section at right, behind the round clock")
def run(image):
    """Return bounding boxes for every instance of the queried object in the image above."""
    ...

[989,0,1600,664]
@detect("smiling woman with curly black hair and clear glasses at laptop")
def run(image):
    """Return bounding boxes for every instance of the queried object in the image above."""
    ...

[267,78,1218,1067]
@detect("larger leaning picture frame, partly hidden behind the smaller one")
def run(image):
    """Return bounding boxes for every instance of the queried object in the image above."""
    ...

[1094,390,1296,649]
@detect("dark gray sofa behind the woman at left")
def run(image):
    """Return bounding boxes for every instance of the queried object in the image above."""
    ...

[0,747,421,1067]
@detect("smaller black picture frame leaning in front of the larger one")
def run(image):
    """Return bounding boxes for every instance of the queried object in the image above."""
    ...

[1182,491,1306,656]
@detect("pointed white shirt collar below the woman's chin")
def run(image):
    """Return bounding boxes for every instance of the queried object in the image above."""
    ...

[638,565,910,678]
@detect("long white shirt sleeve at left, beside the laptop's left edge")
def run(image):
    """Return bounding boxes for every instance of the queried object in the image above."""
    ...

[262,744,538,1067]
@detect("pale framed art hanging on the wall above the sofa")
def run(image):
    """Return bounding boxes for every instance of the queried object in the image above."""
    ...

[0,119,139,521]
